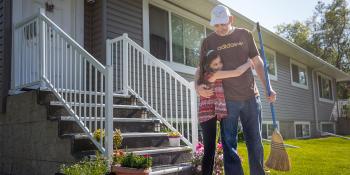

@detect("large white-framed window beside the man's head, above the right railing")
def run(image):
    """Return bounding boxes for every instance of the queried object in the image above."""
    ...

[149,3,208,71]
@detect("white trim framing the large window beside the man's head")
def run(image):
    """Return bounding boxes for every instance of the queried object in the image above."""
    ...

[148,0,214,75]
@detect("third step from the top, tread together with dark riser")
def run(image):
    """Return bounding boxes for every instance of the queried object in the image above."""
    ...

[59,116,160,135]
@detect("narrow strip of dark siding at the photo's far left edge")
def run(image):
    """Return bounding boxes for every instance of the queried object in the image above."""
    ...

[0,0,12,112]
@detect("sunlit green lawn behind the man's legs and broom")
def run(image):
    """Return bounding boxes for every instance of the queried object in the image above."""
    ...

[238,137,350,175]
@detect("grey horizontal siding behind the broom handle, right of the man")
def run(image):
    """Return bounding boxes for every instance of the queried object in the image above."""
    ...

[256,52,314,121]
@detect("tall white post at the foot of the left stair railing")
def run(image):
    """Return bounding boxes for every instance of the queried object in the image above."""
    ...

[105,39,114,161]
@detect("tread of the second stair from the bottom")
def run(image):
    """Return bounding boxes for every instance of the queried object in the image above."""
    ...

[122,146,192,155]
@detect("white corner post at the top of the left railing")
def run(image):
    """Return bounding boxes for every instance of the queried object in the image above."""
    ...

[38,8,46,88]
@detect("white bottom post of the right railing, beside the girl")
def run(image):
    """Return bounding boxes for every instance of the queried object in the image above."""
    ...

[191,82,198,151]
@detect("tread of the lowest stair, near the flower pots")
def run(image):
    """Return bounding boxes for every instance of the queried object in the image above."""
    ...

[150,163,192,175]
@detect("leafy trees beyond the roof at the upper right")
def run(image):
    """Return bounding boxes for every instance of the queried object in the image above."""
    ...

[276,0,350,98]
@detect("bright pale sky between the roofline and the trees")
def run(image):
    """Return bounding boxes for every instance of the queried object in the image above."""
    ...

[219,0,350,32]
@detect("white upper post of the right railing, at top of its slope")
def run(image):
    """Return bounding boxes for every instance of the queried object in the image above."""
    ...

[121,33,129,94]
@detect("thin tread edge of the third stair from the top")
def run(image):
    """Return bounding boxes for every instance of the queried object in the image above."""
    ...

[60,116,160,122]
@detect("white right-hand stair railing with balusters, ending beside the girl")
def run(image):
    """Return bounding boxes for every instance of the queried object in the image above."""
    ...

[107,34,198,146]
